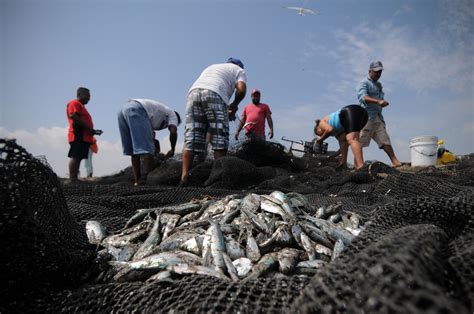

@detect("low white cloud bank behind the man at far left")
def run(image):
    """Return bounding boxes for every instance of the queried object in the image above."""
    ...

[0,127,130,177]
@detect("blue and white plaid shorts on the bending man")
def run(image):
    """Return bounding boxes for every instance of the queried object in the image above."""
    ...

[184,88,229,153]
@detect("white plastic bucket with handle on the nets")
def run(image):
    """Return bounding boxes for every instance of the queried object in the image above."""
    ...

[410,136,438,167]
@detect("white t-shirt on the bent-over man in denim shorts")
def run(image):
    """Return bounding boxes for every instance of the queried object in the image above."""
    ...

[131,99,178,130]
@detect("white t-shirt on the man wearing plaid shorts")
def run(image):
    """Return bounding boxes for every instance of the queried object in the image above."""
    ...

[189,63,247,105]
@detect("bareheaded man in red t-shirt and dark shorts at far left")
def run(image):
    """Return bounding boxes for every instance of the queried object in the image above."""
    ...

[66,87,102,182]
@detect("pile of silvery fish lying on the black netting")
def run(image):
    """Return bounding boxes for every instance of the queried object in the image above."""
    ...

[86,191,367,282]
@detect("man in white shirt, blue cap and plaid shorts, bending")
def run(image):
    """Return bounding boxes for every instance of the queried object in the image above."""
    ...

[180,58,247,186]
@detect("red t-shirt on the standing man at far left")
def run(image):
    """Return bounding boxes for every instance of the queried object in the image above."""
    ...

[66,99,94,143]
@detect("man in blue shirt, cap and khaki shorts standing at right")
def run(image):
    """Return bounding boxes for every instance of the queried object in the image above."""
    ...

[357,61,401,167]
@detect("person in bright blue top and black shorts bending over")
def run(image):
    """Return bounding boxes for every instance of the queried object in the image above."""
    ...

[314,105,368,169]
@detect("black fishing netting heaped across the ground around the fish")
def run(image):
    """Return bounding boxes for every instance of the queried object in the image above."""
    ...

[0,139,474,313]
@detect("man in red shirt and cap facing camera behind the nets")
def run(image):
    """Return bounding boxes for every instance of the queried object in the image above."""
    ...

[235,88,273,140]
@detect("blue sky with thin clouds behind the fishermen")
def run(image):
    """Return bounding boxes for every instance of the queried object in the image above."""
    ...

[0,0,474,176]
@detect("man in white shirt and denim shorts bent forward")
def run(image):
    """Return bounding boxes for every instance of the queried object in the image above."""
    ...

[118,99,181,185]
